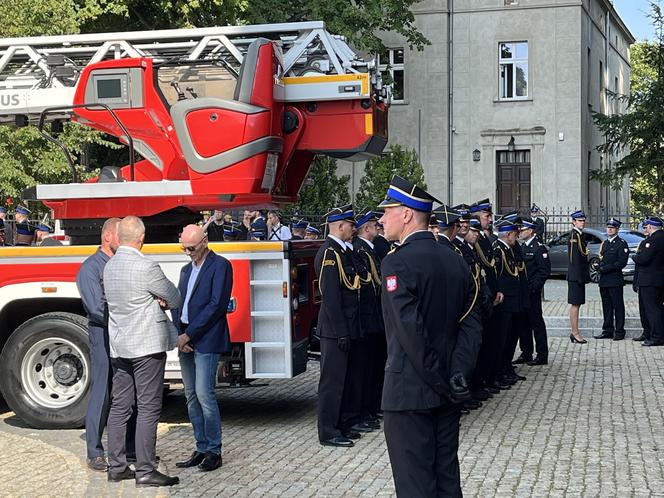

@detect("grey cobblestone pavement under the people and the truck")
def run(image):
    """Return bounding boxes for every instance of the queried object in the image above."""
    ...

[0,338,664,497]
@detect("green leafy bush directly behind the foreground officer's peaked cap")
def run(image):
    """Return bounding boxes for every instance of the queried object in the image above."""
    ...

[355,144,427,208]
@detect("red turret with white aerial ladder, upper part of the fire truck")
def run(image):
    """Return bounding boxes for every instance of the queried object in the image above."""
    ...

[0,22,390,242]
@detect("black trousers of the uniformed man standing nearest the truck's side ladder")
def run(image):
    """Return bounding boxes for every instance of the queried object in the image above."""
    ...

[318,337,348,441]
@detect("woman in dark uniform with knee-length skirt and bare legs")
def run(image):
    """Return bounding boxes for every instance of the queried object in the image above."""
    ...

[567,211,590,344]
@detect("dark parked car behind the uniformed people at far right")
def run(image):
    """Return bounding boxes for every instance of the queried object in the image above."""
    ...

[548,228,645,283]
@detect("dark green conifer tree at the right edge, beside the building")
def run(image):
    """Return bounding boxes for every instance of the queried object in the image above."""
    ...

[591,2,664,213]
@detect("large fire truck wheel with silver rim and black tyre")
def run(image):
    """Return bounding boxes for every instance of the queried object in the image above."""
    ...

[0,313,90,429]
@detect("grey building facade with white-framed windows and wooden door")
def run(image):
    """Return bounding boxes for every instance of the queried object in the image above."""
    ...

[340,0,635,214]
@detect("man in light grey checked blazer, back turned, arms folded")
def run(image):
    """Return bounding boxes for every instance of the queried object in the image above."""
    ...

[104,216,182,487]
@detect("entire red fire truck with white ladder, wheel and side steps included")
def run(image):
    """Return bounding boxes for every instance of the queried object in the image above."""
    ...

[0,22,389,428]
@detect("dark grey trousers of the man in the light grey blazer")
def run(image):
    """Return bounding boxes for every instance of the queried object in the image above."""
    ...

[108,353,166,477]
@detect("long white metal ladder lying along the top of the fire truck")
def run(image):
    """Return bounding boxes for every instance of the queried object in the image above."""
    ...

[0,21,388,126]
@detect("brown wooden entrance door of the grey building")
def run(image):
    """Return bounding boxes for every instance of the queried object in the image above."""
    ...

[496,150,531,215]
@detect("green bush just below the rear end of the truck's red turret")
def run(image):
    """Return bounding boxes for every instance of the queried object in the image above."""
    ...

[284,156,350,217]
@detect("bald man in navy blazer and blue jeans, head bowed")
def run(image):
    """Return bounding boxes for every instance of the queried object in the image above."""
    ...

[173,225,233,471]
